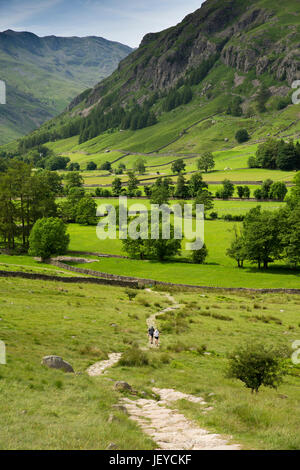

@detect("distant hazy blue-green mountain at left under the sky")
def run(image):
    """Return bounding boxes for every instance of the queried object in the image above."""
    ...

[0,30,132,143]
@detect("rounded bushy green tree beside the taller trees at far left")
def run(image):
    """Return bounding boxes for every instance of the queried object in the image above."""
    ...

[29,217,70,259]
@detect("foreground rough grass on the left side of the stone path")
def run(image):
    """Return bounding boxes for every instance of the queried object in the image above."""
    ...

[0,279,159,449]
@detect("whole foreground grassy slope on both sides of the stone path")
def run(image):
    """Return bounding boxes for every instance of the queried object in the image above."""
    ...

[0,279,300,450]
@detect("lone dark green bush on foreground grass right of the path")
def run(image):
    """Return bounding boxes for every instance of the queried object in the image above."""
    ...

[228,343,286,393]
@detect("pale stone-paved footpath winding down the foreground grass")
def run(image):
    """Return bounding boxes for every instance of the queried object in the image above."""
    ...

[87,289,240,450]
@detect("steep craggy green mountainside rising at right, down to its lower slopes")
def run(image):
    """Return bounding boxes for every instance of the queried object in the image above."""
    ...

[14,0,300,156]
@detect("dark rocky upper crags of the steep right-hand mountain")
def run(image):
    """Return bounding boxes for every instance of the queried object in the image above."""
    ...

[74,0,300,113]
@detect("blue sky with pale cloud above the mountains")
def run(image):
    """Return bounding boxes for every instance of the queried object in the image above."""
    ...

[0,0,204,47]
